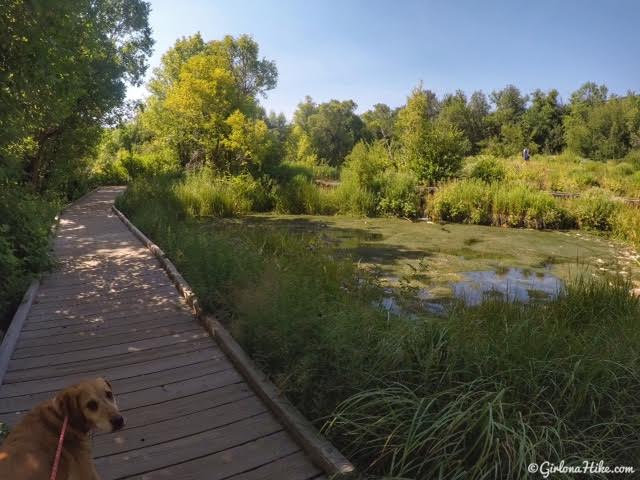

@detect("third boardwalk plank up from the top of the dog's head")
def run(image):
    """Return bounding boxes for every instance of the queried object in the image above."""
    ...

[9,327,208,372]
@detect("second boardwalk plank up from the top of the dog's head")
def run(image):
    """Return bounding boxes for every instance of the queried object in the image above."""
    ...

[4,338,213,383]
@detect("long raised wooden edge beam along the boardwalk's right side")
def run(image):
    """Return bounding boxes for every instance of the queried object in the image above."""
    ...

[111,205,355,478]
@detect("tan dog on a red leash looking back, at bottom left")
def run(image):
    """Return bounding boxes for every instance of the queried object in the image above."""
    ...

[0,378,124,480]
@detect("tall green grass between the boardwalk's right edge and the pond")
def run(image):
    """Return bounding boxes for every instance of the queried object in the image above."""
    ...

[119,178,640,480]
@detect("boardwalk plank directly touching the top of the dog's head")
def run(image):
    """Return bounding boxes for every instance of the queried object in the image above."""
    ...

[0,347,219,398]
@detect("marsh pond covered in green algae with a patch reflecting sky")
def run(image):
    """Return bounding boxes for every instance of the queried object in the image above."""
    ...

[228,214,640,313]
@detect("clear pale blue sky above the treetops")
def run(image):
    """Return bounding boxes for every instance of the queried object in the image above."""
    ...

[129,0,640,118]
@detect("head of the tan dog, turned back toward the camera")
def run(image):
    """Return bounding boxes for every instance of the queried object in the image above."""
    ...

[54,378,124,433]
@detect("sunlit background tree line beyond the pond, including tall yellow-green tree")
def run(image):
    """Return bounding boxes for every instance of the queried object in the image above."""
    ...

[102,34,640,189]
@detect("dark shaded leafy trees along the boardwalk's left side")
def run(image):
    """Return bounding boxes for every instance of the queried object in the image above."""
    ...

[0,0,153,326]
